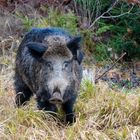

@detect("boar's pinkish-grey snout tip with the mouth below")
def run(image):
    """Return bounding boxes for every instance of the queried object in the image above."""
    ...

[49,92,63,104]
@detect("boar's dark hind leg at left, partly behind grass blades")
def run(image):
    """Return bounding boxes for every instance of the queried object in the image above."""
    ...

[15,73,33,107]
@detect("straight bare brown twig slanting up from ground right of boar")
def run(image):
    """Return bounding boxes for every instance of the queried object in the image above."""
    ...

[95,52,126,83]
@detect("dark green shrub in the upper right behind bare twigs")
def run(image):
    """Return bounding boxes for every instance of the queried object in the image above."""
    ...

[92,3,140,61]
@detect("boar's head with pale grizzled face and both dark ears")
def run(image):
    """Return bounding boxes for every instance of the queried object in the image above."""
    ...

[27,37,83,104]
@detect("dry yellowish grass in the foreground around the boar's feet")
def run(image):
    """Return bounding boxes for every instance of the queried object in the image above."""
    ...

[0,46,140,140]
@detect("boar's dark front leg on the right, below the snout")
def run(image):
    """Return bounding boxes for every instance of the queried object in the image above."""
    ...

[62,98,76,124]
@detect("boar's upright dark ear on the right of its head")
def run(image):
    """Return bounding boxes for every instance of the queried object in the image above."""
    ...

[67,36,84,64]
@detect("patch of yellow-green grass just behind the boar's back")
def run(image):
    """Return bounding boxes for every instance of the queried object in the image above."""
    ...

[14,8,78,35]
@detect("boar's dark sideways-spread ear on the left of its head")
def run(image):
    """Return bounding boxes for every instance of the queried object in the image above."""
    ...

[26,42,47,58]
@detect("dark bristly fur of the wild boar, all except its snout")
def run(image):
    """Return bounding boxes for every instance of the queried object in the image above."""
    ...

[15,28,83,123]
